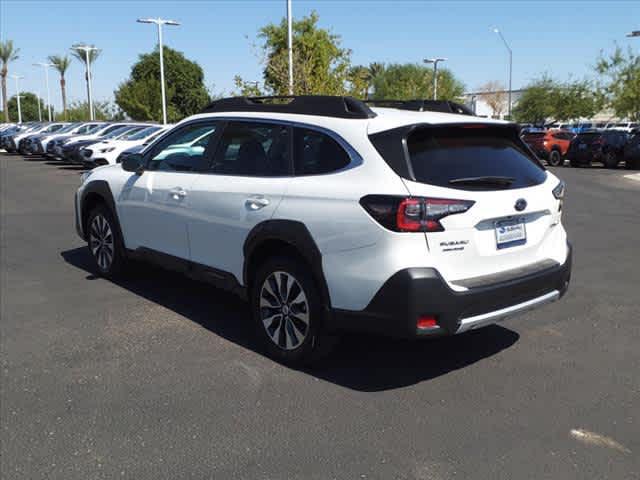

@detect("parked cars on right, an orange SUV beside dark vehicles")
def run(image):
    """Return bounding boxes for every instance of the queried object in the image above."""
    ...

[522,128,640,169]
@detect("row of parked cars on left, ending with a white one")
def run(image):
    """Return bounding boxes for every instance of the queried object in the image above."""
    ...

[0,122,172,168]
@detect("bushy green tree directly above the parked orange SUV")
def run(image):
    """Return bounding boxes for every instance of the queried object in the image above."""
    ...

[513,75,602,124]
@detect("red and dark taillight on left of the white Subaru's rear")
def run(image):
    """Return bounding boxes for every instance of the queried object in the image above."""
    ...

[360,195,475,232]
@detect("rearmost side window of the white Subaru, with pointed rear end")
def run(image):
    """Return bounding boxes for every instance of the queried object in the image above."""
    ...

[294,128,351,175]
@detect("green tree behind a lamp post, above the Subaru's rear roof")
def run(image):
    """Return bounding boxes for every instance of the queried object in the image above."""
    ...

[373,63,464,100]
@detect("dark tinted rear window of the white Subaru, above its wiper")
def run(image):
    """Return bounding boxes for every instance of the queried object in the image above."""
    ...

[407,127,546,190]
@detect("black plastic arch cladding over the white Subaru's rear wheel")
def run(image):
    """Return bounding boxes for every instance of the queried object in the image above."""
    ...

[242,220,331,308]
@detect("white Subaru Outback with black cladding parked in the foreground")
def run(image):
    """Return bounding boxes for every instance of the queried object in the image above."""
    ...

[75,96,571,364]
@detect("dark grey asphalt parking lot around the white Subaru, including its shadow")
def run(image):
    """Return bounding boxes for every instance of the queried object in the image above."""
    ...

[0,153,640,480]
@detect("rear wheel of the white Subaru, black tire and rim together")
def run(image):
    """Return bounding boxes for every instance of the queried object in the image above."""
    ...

[250,256,335,367]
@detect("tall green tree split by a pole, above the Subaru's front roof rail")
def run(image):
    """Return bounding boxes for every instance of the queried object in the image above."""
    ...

[250,12,351,95]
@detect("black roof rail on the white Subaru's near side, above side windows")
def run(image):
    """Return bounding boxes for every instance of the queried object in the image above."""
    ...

[202,95,376,119]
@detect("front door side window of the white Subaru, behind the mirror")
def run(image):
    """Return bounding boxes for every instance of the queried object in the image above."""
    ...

[147,123,216,172]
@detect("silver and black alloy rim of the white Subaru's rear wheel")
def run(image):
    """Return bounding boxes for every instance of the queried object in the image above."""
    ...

[260,271,309,350]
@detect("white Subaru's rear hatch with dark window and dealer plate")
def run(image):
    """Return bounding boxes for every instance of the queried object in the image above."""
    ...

[374,124,560,285]
